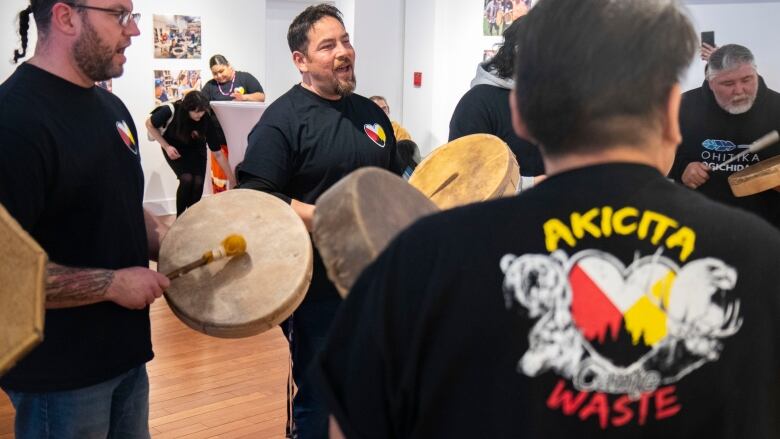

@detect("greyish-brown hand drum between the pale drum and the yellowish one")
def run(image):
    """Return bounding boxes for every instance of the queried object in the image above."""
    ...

[312,167,439,297]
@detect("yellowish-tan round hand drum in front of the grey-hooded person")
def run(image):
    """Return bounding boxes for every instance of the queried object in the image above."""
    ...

[409,134,520,209]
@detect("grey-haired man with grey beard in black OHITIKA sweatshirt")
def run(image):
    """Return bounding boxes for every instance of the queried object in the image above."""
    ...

[669,44,780,227]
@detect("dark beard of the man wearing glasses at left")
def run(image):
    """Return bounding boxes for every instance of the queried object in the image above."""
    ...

[73,15,124,82]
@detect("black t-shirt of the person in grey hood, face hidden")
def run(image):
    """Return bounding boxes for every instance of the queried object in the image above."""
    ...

[449,84,544,177]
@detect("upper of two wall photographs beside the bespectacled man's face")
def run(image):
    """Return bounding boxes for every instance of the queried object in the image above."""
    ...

[152,14,203,59]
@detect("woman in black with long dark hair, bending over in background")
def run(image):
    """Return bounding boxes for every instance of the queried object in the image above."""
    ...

[146,90,235,216]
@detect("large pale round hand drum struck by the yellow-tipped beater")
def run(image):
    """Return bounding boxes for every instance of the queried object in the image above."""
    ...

[158,189,313,338]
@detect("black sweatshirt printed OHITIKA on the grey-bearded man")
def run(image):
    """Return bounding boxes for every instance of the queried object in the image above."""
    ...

[669,78,780,228]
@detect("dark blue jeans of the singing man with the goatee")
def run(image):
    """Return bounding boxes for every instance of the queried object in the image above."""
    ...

[281,296,341,439]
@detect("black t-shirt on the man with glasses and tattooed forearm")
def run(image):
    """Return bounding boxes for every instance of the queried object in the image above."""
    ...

[0,64,152,391]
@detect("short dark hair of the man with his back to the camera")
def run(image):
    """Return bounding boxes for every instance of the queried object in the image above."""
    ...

[515,0,699,156]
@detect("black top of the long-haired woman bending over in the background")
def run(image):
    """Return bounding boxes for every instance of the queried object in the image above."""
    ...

[150,105,222,157]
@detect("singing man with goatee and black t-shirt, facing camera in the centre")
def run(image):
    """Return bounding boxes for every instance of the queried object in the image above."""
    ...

[238,4,401,438]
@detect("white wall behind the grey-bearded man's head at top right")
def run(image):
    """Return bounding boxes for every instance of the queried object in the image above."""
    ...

[683,2,780,90]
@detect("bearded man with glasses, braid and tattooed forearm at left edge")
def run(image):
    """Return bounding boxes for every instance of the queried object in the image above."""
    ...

[0,0,168,438]
